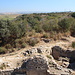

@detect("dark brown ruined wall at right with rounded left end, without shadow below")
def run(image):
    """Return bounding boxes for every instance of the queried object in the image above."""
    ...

[52,46,75,61]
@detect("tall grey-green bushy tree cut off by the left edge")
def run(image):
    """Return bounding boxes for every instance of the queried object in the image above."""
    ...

[0,20,10,45]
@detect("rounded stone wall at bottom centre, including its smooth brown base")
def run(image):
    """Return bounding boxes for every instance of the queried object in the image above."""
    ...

[23,56,48,75]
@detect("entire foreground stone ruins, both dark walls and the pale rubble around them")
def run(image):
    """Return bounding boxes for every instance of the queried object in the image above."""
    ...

[0,46,75,75]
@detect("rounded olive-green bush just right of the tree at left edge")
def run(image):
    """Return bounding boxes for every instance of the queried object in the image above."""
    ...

[10,23,26,38]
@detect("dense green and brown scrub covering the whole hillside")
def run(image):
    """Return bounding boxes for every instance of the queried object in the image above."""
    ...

[0,12,75,53]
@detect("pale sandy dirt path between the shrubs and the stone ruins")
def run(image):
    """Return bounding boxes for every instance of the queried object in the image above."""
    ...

[0,36,75,70]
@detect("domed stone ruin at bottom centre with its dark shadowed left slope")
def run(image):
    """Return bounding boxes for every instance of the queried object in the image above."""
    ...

[12,55,49,75]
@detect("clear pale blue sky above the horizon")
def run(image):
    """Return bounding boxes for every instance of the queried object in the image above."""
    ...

[0,0,75,13]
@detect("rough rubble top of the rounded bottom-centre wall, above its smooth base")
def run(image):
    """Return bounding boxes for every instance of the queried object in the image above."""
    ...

[26,55,48,70]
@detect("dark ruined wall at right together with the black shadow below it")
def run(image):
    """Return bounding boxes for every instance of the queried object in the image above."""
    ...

[52,46,75,70]
